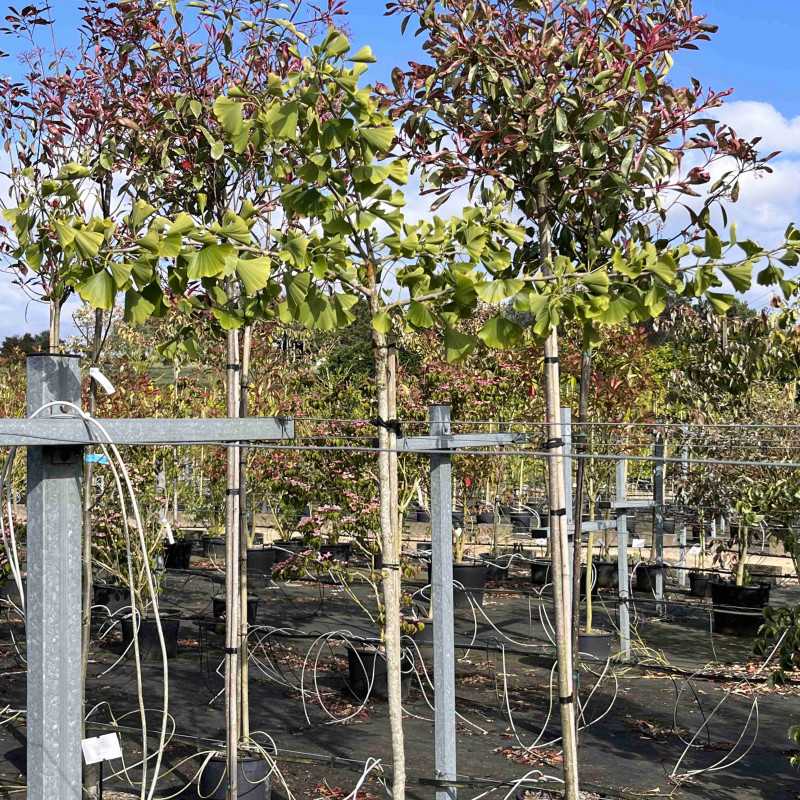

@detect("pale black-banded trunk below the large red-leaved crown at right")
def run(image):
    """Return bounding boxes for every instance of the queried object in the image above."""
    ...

[537,186,580,800]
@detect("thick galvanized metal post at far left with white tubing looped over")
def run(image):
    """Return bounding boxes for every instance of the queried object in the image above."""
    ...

[26,354,83,800]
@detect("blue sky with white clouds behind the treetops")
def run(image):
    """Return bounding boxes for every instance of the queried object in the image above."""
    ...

[0,0,800,337]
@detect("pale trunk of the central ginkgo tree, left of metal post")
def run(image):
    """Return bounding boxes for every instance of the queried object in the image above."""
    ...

[372,326,406,800]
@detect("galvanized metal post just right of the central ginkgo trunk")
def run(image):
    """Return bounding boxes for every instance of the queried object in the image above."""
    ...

[430,406,456,800]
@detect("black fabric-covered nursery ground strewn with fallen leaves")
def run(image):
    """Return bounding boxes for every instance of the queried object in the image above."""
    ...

[0,571,800,800]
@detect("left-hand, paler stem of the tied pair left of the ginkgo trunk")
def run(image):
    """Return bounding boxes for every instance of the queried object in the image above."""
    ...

[225,331,241,800]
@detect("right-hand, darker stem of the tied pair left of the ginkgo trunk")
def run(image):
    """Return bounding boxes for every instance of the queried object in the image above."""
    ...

[239,325,253,741]
